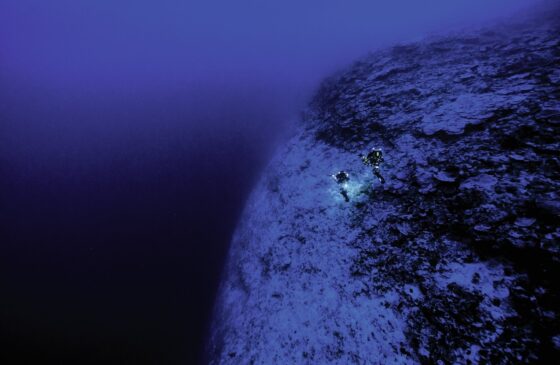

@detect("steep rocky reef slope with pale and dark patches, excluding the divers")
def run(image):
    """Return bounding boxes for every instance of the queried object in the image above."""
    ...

[210,12,560,364]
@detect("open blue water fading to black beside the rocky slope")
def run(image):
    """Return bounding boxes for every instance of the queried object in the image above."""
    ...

[0,0,534,364]
